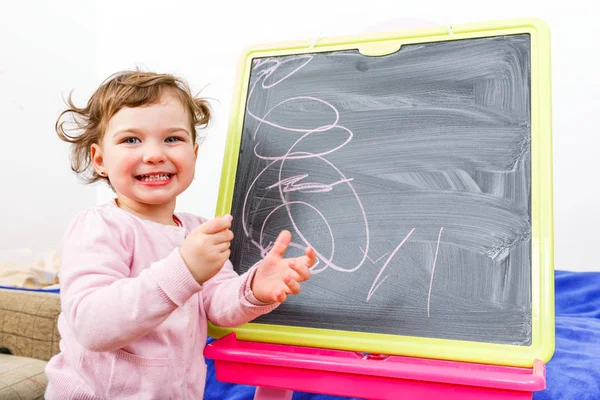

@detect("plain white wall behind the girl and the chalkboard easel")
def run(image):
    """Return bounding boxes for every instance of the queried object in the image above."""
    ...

[0,0,600,271]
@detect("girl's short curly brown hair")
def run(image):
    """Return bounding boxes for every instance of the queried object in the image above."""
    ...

[55,69,211,186]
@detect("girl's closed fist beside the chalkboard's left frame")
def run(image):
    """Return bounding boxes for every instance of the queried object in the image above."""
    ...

[179,215,233,285]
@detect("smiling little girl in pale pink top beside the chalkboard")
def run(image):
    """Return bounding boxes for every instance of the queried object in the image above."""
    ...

[46,71,316,400]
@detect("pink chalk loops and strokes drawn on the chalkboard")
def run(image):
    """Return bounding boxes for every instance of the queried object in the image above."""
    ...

[242,55,443,306]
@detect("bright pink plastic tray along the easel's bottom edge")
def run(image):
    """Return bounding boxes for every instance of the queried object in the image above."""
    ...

[204,333,546,400]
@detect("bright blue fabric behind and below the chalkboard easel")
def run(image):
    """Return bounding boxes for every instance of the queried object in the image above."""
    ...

[204,271,600,400]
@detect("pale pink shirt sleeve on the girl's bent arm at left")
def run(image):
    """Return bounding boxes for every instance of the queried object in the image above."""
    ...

[59,209,201,351]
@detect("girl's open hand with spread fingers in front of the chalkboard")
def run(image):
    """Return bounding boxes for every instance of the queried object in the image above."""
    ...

[250,231,317,303]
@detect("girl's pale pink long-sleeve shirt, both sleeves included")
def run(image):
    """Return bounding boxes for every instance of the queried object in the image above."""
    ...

[46,202,279,400]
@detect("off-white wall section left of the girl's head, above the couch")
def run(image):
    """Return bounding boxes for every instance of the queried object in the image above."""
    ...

[0,0,96,253]
